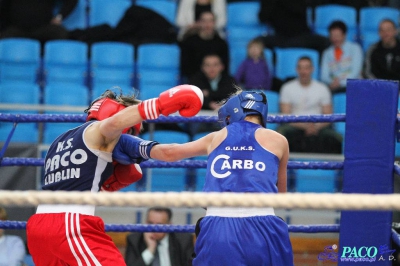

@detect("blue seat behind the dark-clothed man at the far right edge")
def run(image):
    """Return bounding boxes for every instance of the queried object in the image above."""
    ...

[359,7,400,51]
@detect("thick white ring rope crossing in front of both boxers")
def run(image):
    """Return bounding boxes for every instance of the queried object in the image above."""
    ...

[0,190,400,210]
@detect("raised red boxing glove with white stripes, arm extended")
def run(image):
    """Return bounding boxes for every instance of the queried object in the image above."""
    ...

[138,85,204,120]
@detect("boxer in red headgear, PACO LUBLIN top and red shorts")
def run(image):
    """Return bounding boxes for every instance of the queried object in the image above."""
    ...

[26,85,203,266]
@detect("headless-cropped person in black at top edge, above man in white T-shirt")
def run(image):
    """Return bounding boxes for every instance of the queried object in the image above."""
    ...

[258,0,329,54]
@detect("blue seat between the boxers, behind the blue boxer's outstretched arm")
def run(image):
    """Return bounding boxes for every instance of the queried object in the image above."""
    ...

[141,130,189,192]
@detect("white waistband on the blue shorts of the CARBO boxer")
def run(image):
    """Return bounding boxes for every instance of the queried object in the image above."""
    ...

[206,207,275,217]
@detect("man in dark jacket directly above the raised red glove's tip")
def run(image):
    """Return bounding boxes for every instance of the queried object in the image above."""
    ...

[189,54,236,110]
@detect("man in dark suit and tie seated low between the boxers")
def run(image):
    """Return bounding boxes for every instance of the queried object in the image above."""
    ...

[125,207,194,266]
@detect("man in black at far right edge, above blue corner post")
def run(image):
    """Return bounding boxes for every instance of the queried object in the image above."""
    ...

[364,19,400,80]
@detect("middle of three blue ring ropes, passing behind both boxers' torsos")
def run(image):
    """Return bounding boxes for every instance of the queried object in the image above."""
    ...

[0,157,343,170]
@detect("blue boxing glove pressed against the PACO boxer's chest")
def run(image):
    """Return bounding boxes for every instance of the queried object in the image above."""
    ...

[112,134,159,164]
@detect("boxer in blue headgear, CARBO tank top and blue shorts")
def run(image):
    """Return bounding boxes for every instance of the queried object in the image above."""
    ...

[133,88,293,266]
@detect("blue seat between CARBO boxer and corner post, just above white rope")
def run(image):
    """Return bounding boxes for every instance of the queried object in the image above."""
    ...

[295,169,338,193]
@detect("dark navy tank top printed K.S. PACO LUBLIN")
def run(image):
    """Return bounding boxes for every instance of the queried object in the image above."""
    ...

[42,121,113,192]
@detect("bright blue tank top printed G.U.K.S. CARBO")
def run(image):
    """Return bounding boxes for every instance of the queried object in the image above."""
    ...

[203,121,279,193]
